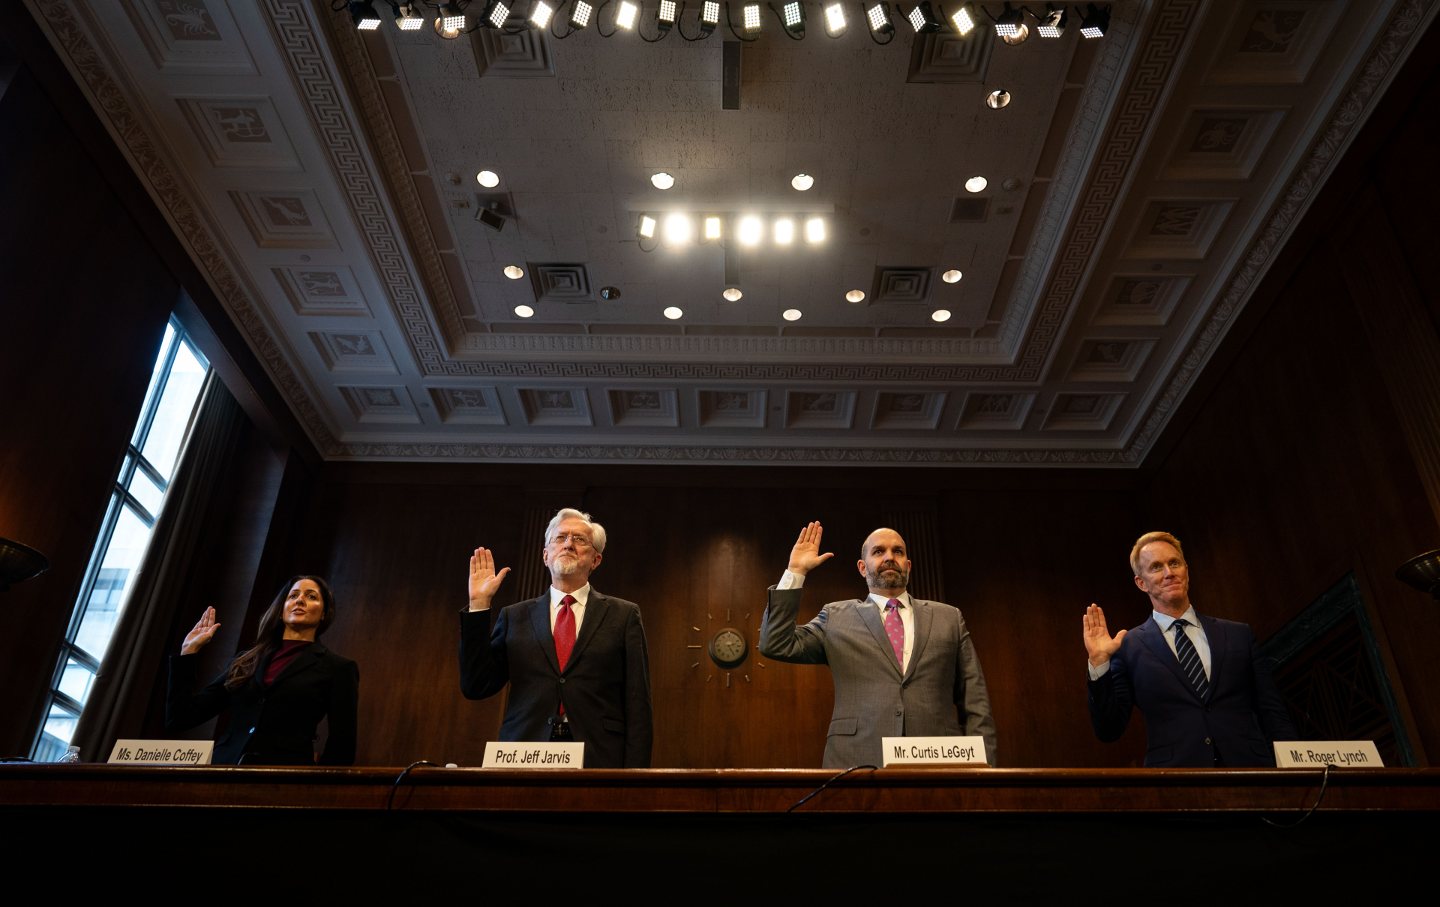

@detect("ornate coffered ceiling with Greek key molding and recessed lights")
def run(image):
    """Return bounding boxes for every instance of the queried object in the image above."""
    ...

[27,0,1437,468]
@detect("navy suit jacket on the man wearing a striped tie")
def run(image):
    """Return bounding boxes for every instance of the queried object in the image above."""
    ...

[1090,612,1297,769]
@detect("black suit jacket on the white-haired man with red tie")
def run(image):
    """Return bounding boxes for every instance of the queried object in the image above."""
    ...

[459,586,654,769]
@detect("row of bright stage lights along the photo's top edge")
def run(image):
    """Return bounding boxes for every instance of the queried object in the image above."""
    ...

[345,0,1110,43]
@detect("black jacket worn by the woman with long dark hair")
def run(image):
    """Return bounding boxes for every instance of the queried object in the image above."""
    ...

[166,642,360,766]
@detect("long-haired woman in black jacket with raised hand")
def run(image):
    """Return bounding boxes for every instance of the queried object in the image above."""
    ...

[166,576,360,766]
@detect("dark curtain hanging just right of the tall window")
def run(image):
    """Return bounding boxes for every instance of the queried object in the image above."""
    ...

[71,373,246,762]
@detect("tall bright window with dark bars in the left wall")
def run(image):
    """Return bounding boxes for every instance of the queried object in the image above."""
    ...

[32,320,210,762]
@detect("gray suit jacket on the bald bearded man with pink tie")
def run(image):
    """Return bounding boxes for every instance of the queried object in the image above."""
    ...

[760,586,995,769]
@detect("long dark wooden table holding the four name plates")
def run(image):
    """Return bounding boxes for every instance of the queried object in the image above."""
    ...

[0,764,1440,903]
